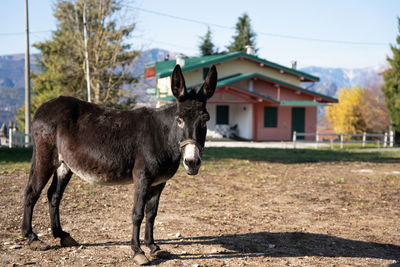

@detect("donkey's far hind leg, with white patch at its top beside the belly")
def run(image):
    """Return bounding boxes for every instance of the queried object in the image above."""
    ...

[47,163,78,247]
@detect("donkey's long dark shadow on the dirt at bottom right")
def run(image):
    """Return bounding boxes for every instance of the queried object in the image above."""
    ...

[76,232,400,266]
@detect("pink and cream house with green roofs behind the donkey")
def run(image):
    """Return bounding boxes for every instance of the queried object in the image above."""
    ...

[145,52,338,141]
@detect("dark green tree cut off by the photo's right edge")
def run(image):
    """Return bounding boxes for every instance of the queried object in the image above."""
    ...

[382,17,400,141]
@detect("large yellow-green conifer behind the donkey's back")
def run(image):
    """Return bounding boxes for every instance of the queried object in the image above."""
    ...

[16,0,137,129]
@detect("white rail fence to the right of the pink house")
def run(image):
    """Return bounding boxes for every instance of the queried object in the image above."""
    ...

[293,131,394,149]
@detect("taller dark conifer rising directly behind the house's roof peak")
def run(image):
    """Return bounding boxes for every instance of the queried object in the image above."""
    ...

[227,13,258,52]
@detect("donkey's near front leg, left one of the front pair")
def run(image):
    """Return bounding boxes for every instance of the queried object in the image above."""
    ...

[131,169,150,265]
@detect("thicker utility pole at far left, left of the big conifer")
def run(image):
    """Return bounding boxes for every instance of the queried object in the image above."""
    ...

[25,0,31,147]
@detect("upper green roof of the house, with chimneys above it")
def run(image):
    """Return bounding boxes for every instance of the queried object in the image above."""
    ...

[153,52,319,81]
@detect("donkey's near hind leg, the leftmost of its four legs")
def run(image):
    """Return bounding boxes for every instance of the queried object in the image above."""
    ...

[22,151,54,250]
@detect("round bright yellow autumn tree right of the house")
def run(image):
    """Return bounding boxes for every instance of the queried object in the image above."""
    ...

[326,87,390,133]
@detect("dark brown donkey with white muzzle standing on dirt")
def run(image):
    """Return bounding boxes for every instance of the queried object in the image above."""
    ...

[22,65,217,265]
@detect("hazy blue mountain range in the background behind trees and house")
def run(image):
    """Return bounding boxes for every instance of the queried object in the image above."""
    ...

[0,49,385,125]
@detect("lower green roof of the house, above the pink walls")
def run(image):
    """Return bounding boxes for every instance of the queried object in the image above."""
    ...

[217,73,338,102]
